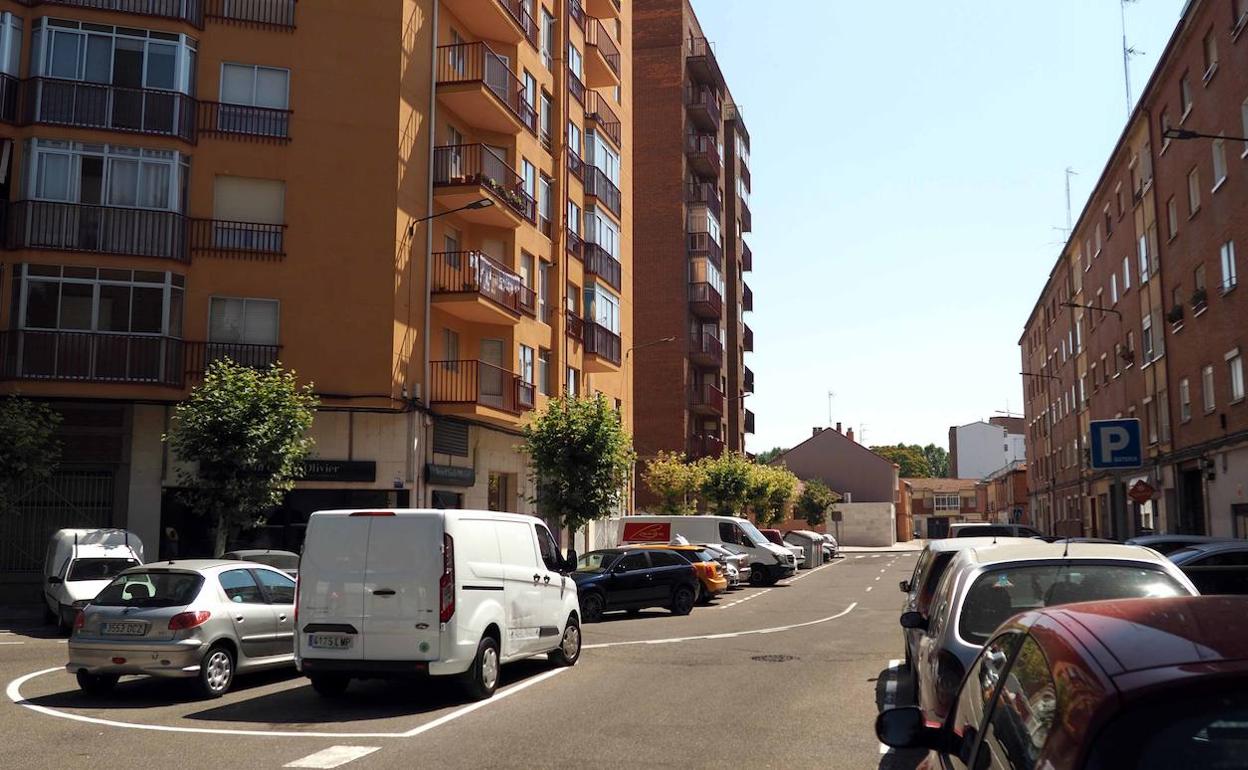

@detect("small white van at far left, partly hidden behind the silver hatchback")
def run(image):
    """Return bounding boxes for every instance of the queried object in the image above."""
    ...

[44,529,144,631]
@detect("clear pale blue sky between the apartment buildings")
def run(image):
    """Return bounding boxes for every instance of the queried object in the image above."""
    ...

[694,0,1183,452]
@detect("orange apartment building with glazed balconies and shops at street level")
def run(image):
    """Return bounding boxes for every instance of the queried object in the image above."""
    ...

[0,0,633,574]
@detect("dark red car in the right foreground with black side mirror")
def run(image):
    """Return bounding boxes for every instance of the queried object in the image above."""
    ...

[876,597,1248,770]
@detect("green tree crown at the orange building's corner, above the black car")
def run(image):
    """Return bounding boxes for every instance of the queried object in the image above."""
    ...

[523,394,635,530]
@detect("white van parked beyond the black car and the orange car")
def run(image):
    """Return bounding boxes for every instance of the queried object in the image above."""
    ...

[612,514,797,585]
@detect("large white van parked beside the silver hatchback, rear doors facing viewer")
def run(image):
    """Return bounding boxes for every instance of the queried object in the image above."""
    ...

[295,510,580,699]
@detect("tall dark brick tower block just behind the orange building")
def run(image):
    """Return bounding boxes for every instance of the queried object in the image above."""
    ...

[631,0,754,474]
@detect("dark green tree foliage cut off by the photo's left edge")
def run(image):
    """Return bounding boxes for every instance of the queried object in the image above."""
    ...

[0,396,61,513]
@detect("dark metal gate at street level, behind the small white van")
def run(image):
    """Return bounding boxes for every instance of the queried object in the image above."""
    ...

[0,470,115,573]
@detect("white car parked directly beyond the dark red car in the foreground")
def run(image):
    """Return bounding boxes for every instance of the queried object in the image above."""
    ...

[901,540,1197,718]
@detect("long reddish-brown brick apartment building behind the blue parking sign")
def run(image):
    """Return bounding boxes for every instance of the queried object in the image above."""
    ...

[1020,0,1248,537]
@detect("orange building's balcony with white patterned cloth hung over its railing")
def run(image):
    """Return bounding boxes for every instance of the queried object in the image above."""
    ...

[429,251,537,324]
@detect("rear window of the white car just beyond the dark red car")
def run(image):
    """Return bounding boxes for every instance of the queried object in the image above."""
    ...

[957,563,1188,644]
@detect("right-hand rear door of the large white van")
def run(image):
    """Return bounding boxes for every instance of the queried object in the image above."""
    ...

[363,513,444,660]
